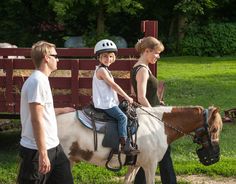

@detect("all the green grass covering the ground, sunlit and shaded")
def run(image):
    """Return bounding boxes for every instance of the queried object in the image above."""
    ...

[0,57,236,184]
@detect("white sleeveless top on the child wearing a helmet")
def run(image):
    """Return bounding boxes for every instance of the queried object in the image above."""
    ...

[93,66,119,109]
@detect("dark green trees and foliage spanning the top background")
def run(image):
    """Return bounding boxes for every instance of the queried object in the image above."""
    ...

[0,0,236,50]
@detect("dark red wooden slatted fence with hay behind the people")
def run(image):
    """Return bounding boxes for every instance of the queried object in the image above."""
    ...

[0,21,157,119]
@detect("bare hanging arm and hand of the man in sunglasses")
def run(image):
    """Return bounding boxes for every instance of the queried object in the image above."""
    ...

[30,103,51,174]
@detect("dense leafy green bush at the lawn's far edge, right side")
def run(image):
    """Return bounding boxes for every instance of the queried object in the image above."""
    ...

[180,23,236,56]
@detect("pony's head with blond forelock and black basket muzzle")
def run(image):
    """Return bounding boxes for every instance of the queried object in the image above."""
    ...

[194,107,223,165]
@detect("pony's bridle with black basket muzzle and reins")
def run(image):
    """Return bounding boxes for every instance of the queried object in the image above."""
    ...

[134,103,220,166]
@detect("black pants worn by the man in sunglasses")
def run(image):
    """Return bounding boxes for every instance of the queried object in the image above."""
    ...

[18,145,73,184]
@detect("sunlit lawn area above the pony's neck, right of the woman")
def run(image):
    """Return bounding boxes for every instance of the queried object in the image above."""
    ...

[158,57,236,110]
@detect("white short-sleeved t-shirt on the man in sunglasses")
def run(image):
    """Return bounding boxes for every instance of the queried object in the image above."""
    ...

[20,70,59,149]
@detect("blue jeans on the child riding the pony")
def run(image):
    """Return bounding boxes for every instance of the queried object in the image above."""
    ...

[103,106,127,138]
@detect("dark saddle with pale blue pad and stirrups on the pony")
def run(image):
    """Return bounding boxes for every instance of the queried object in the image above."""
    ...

[77,100,139,171]
